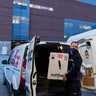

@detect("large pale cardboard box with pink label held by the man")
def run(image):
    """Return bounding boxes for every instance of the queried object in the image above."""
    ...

[47,52,69,80]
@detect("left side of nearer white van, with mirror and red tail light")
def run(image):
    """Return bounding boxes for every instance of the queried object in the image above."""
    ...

[2,43,29,96]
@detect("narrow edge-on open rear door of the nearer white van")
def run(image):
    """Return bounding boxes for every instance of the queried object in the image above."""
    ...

[25,36,38,96]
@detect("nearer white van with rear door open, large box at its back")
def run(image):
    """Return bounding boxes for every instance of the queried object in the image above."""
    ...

[2,36,70,96]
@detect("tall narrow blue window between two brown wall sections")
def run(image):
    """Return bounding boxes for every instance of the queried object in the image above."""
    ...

[12,0,30,41]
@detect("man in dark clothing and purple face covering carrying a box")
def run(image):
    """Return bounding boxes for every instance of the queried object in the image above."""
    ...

[62,42,82,96]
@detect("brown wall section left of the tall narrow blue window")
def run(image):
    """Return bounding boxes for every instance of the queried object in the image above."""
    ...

[0,0,13,40]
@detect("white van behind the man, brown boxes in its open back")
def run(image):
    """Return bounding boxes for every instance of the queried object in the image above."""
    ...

[67,29,96,90]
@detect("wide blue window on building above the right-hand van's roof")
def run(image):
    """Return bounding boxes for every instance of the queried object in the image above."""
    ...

[64,19,96,41]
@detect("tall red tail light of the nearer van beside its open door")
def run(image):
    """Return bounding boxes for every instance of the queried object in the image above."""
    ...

[21,60,26,85]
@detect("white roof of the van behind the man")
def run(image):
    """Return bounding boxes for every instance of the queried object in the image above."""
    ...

[67,29,96,43]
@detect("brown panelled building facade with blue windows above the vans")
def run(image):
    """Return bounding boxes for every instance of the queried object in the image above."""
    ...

[0,0,96,41]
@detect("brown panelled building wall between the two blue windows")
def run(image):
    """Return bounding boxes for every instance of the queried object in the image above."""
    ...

[29,0,96,41]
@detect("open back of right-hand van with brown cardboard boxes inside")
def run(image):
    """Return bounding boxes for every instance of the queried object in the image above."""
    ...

[79,40,96,89]
